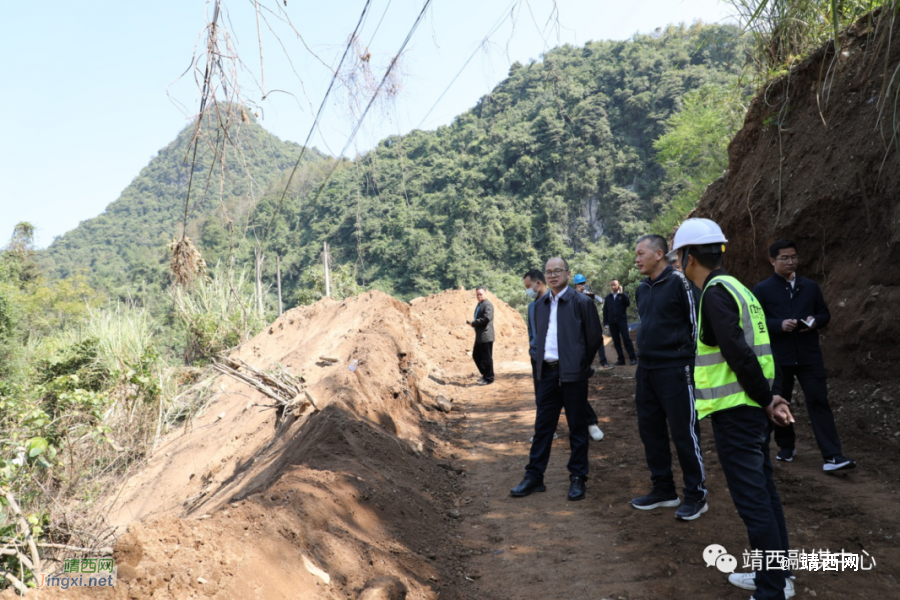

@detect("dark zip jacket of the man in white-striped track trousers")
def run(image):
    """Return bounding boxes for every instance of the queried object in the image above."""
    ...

[634,267,700,369]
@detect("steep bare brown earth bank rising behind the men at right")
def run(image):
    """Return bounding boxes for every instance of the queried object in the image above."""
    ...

[695,13,900,380]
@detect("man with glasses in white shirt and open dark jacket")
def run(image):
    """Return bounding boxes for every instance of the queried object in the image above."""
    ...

[510,258,603,501]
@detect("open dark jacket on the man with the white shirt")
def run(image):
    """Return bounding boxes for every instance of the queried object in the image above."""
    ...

[534,287,603,383]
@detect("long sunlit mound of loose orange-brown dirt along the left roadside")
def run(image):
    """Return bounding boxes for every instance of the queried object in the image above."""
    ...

[24,291,527,599]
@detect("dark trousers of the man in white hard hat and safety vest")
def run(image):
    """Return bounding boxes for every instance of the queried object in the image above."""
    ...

[710,406,789,600]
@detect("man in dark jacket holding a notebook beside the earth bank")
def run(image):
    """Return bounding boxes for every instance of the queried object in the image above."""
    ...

[753,240,856,472]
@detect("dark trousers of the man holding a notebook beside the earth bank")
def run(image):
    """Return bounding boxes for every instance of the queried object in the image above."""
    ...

[774,365,841,459]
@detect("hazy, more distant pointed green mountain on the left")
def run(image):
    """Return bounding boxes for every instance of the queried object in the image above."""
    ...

[41,111,321,297]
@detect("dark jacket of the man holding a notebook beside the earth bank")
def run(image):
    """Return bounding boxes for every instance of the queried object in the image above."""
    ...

[753,273,831,366]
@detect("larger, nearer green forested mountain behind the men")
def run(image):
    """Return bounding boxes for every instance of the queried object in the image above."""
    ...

[248,25,744,296]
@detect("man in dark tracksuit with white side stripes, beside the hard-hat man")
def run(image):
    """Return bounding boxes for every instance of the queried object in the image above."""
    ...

[631,235,708,521]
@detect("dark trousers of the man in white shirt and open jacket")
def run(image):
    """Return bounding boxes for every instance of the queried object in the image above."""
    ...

[525,366,588,481]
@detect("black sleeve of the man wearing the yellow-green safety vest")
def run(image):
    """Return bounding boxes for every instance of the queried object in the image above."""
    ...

[699,269,781,407]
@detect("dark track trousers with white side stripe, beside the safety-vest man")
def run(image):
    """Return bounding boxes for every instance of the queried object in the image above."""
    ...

[634,366,706,501]
